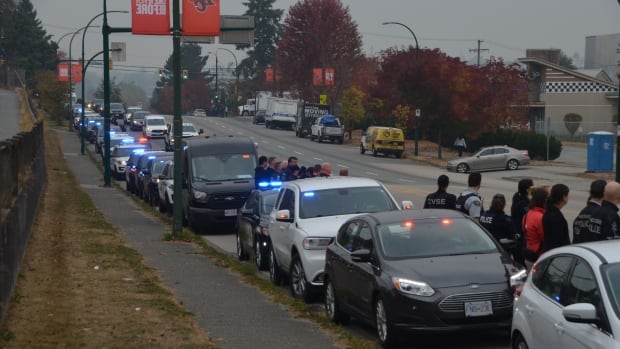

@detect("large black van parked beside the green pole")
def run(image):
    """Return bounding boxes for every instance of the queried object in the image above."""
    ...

[182,136,258,233]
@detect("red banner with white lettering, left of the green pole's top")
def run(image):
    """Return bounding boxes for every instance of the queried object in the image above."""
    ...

[131,0,170,35]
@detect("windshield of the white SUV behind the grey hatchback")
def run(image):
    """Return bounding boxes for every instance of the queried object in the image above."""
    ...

[299,187,398,218]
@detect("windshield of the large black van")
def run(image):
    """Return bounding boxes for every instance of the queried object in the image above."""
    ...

[192,154,256,182]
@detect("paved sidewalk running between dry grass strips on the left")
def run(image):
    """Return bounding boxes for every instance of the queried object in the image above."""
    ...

[55,128,338,349]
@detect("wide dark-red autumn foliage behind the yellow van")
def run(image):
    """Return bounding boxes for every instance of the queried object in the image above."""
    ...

[373,48,527,158]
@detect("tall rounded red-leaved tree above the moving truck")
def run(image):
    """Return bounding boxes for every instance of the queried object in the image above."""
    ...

[277,0,362,104]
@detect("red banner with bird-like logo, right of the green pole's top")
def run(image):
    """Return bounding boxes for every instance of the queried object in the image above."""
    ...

[181,0,220,36]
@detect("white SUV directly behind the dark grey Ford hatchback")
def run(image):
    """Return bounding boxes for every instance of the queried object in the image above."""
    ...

[268,176,412,301]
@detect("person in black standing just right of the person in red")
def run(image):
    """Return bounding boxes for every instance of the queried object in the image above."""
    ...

[542,184,570,252]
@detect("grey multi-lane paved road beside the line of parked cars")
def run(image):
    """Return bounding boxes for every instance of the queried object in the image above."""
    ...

[106,116,600,348]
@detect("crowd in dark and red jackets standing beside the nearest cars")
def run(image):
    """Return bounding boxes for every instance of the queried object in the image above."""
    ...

[424,172,620,269]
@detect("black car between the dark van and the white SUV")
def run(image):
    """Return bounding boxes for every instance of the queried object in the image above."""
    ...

[236,189,279,270]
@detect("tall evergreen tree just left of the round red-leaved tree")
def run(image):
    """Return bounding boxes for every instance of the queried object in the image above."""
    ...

[237,0,284,82]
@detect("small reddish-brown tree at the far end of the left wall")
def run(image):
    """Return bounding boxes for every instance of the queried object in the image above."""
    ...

[35,70,69,125]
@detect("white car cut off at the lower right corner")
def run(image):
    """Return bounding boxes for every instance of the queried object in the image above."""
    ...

[511,240,620,349]
